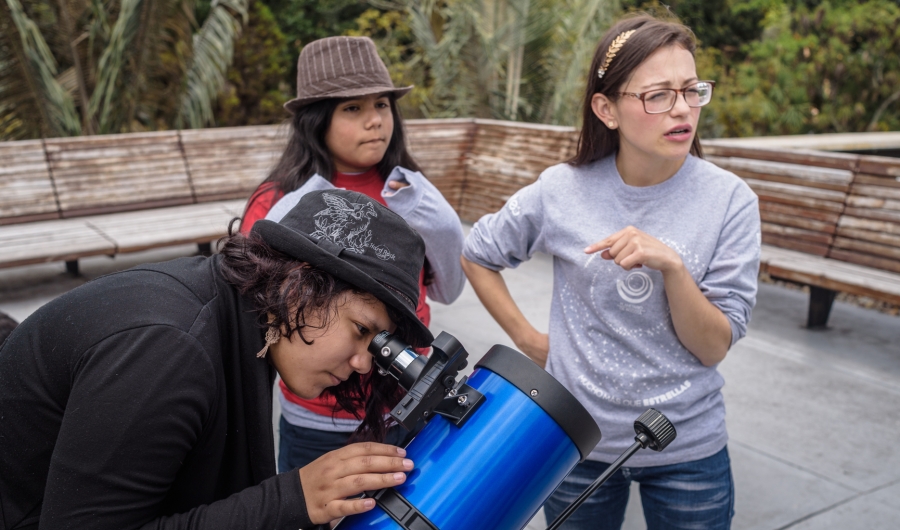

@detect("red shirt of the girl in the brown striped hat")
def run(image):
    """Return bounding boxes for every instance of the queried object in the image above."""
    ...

[241,167,431,419]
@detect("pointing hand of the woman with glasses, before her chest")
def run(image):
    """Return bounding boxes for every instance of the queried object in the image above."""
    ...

[584,226,683,275]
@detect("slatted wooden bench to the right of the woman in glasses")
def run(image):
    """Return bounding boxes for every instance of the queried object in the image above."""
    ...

[706,143,900,329]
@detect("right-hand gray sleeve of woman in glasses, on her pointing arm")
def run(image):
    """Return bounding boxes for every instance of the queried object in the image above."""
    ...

[699,183,761,346]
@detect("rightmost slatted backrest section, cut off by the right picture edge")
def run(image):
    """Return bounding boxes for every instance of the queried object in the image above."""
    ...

[828,156,900,272]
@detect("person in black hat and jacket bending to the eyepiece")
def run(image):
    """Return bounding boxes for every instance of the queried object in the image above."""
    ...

[0,190,432,530]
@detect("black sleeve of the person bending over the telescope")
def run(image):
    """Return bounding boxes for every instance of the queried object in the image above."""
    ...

[40,325,311,530]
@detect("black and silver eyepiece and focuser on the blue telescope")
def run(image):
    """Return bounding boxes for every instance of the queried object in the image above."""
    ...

[369,331,484,430]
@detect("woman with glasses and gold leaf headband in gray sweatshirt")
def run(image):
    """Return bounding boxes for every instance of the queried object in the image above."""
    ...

[462,15,760,530]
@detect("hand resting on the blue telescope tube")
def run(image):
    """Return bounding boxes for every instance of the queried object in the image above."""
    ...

[300,442,413,524]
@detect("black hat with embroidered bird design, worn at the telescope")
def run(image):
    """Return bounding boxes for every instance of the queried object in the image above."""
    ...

[253,189,434,347]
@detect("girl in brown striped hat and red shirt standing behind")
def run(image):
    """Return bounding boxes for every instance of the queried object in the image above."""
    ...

[241,37,465,471]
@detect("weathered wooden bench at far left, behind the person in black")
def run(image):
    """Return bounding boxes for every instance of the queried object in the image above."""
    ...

[0,127,281,274]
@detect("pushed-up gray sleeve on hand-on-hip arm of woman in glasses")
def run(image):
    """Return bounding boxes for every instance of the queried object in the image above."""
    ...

[463,172,546,271]
